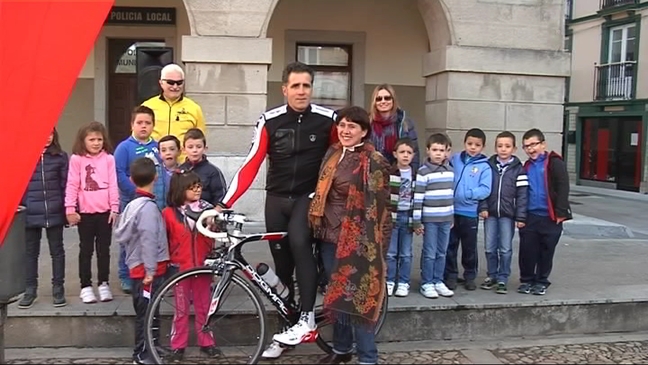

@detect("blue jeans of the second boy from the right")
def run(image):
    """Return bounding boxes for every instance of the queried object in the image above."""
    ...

[484,217,515,284]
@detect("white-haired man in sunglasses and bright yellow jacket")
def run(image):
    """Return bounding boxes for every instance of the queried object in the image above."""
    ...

[142,63,207,163]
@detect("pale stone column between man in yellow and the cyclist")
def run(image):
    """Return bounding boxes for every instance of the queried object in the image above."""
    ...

[182,36,272,220]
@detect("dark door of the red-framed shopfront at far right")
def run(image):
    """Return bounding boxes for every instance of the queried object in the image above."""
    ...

[616,119,643,191]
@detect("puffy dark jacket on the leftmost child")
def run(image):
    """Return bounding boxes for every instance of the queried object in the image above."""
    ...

[21,147,68,228]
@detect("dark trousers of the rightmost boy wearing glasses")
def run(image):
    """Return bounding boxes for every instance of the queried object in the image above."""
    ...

[519,214,562,287]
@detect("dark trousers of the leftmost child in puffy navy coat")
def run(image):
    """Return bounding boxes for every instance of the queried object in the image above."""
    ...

[25,226,65,294]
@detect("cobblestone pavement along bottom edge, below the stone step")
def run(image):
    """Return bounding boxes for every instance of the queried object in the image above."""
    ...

[7,341,648,364]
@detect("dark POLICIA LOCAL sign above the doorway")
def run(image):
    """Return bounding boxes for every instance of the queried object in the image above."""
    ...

[106,6,176,25]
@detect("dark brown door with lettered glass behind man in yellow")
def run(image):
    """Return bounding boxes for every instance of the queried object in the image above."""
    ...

[107,39,165,146]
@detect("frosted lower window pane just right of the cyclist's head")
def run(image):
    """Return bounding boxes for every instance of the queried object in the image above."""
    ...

[313,71,351,109]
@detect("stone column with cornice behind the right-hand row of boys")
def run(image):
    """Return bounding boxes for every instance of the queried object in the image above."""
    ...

[423,46,569,152]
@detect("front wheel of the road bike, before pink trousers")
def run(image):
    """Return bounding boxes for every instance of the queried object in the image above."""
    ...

[144,267,267,364]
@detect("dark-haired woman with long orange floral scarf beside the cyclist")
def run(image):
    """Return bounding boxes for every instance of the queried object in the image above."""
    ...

[309,106,392,364]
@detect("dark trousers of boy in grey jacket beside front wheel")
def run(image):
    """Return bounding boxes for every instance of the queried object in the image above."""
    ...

[131,276,165,360]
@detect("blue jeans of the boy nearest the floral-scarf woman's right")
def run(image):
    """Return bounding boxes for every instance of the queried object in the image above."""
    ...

[387,211,412,284]
